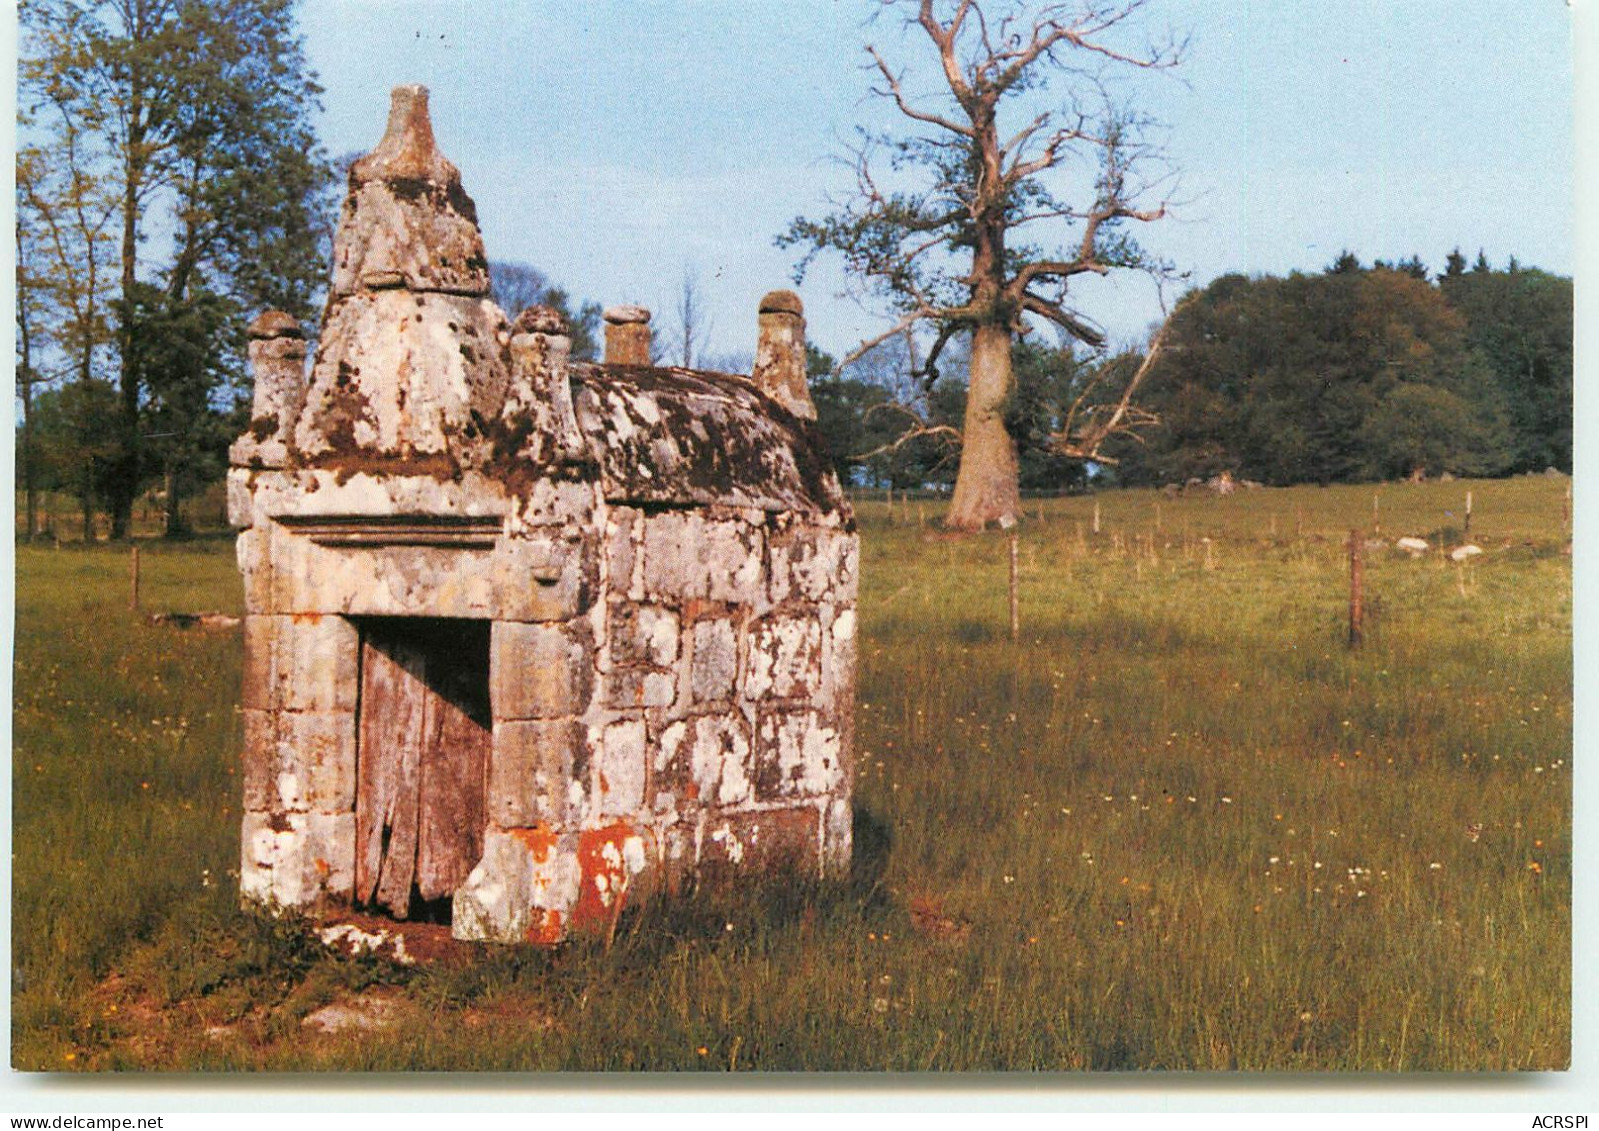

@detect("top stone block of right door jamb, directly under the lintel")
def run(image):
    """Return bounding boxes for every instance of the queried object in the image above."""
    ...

[489,621,592,720]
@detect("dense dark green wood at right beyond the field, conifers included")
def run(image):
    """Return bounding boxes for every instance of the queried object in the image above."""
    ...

[1115,251,1572,485]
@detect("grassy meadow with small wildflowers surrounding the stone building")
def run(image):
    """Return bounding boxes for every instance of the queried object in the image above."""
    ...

[13,478,1572,1072]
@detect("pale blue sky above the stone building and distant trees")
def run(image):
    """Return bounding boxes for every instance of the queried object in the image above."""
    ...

[302,0,1575,363]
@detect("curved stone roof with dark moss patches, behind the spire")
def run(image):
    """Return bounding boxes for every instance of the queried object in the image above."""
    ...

[571,363,844,512]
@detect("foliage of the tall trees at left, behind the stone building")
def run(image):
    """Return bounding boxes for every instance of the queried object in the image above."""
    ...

[19,0,329,536]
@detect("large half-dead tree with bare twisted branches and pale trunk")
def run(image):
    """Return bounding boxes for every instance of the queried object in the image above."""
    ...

[779,0,1177,530]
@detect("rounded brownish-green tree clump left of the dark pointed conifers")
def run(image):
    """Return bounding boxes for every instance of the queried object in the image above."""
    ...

[1122,265,1508,483]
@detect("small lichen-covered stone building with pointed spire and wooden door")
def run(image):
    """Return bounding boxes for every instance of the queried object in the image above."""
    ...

[229,86,857,942]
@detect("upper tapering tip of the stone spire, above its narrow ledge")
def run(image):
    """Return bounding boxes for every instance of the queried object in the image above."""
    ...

[333,86,489,299]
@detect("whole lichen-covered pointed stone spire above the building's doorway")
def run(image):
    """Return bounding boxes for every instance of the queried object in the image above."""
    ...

[294,86,510,463]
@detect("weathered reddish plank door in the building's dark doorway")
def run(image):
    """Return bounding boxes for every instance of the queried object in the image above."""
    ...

[355,617,492,918]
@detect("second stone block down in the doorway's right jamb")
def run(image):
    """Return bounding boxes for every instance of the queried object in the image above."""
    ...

[488,718,587,829]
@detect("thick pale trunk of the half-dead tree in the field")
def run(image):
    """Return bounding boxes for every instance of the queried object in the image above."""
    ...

[943,325,1022,530]
